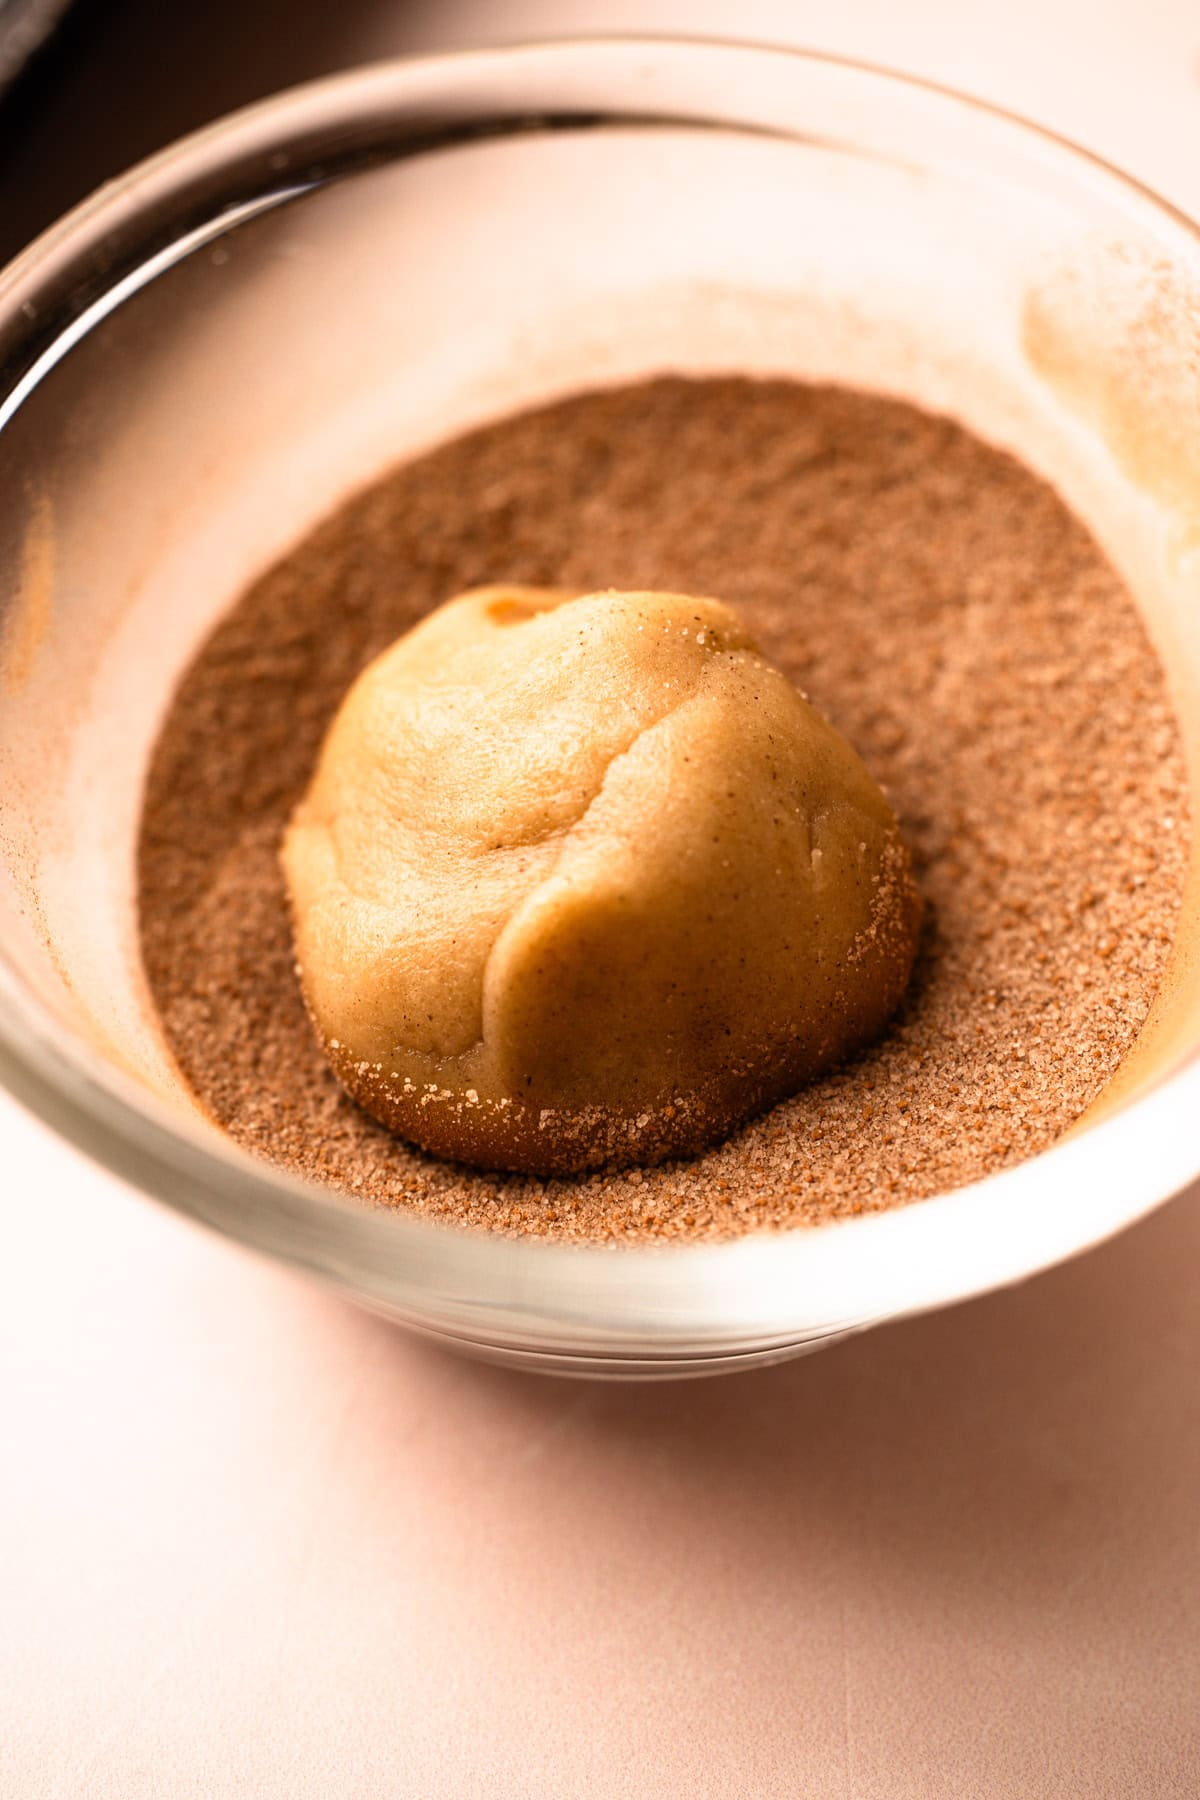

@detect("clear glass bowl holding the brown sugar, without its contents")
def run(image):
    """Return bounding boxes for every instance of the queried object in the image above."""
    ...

[0,40,1200,1375]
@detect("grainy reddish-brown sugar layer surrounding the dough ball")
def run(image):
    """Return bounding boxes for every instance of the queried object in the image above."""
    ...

[139,378,1187,1242]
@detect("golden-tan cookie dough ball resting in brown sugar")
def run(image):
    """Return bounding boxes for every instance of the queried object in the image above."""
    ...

[282,587,919,1174]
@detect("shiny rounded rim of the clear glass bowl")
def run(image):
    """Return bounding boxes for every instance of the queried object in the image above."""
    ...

[0,34,1200,1373]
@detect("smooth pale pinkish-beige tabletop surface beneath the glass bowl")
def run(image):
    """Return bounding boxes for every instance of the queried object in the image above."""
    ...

[0,0,1200,1800]
